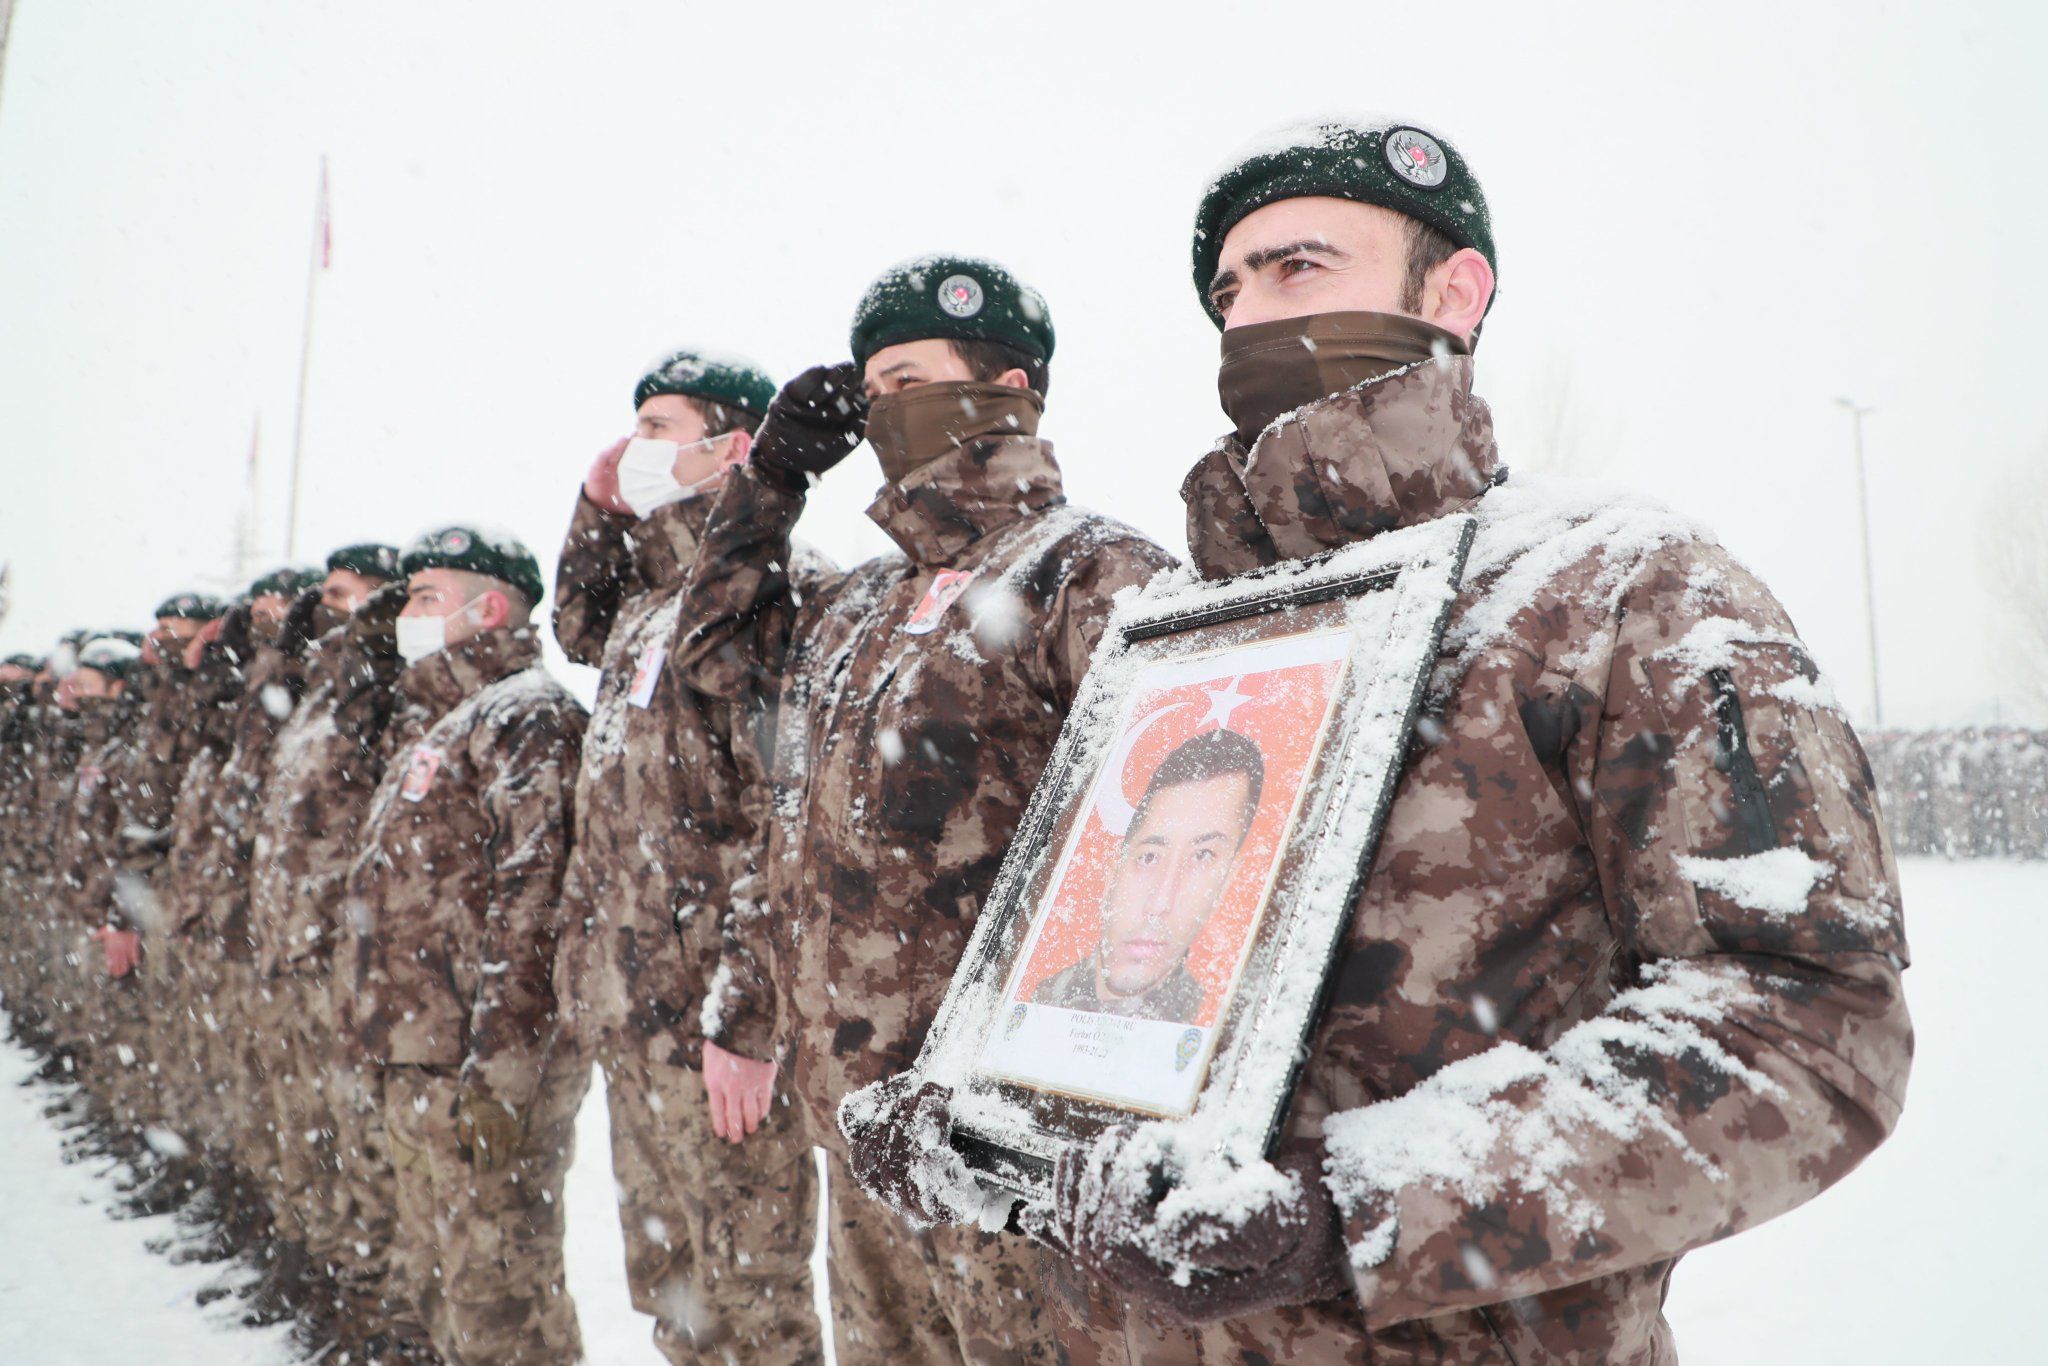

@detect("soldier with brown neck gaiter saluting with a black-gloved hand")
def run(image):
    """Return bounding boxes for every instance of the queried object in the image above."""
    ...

[678,258,1171,1362]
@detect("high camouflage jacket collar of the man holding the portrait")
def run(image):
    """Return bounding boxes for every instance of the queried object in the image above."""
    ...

[1182,356,1501,578]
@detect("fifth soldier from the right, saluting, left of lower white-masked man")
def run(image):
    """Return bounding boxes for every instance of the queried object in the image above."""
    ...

[248,543,406,1327]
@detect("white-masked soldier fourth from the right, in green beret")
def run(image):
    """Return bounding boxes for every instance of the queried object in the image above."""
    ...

[342,526,590,1362]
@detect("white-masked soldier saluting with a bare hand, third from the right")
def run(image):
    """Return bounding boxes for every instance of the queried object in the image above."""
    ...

[555,352,823,1366]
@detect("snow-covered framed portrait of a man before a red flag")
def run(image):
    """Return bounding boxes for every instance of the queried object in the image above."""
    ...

[915,516,1475,1196]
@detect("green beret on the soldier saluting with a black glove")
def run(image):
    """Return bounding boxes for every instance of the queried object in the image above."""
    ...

[852,256,1053,367]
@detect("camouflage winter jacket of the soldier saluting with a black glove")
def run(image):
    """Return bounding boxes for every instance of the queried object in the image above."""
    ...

[678,436,1174,1145]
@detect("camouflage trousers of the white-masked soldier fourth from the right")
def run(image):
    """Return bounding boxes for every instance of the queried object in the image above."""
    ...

[383,1057,590,1366]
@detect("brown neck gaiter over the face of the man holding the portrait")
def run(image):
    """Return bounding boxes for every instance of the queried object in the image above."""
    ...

[1217,313,1470,446]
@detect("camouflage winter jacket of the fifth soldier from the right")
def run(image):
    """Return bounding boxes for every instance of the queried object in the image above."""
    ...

[248,627,401,977]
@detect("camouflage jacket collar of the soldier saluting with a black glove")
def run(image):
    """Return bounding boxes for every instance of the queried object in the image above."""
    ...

[868,436,1065,567]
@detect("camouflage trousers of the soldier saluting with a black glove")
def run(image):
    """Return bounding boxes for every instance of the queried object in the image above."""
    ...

[825,1149,1059,1366]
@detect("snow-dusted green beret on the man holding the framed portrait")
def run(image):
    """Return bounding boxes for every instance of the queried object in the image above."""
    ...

[1194,121,1499,328]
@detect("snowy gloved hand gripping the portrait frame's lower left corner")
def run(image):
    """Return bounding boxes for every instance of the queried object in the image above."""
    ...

[840,1073,995,1229]
